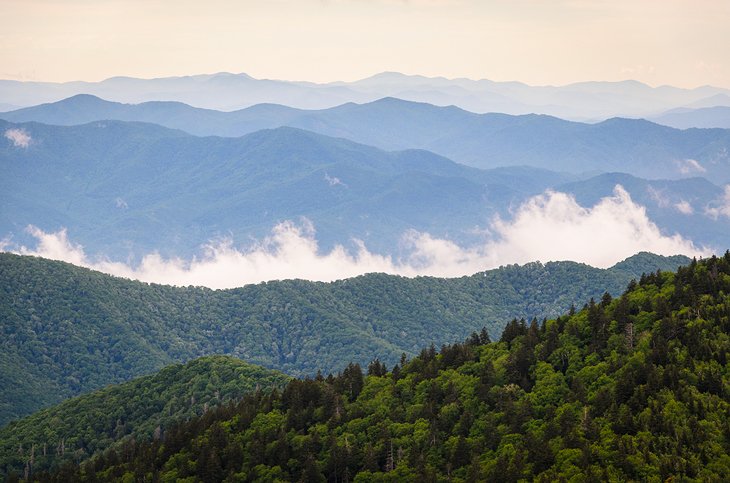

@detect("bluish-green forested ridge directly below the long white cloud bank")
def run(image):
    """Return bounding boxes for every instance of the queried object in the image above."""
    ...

[0,253,689,427]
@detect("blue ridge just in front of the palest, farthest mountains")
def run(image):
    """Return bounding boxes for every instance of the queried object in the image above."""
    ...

[5,95,730,182]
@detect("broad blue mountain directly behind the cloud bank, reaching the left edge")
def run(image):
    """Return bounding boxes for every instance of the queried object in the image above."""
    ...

[0,117,575,256]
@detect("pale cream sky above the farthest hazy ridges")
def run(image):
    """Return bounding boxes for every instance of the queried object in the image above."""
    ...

[0,0,730,88]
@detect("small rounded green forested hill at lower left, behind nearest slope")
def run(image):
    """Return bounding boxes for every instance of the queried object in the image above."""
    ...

[0,356,290,475]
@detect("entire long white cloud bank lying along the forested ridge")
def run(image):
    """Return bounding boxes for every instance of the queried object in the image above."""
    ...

[5,186,709,288]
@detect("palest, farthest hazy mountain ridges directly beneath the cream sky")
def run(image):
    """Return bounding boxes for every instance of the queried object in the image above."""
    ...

[0,72,730,120]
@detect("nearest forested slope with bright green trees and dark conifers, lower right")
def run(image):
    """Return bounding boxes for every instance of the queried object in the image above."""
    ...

[7,252,730,482]
